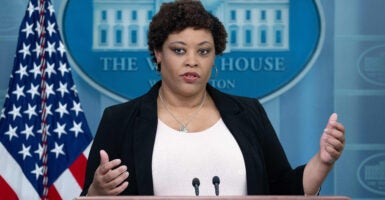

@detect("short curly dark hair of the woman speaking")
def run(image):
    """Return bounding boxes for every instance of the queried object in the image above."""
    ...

[148,0,227,70]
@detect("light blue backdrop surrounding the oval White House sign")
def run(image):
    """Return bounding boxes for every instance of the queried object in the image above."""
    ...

[0,0,385,199]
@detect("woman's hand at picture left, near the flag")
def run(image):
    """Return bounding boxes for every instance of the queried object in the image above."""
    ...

[87,150,129,196]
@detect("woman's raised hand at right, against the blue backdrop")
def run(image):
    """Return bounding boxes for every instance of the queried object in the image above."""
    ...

[320,113,345,164]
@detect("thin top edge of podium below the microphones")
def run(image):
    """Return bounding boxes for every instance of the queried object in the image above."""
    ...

[74,195,350,200]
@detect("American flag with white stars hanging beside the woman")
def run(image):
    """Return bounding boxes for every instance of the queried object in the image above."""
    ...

[0,0,93,199]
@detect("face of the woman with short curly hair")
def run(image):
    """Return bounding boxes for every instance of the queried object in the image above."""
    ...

[155,28,215,96]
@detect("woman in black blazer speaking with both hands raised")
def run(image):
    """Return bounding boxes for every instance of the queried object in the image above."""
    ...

[82,0,345,196]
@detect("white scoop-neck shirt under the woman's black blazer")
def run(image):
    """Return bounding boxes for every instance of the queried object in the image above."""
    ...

[152,119,247,196]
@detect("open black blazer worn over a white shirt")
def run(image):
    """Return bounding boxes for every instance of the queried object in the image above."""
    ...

[82,82,304,195]
